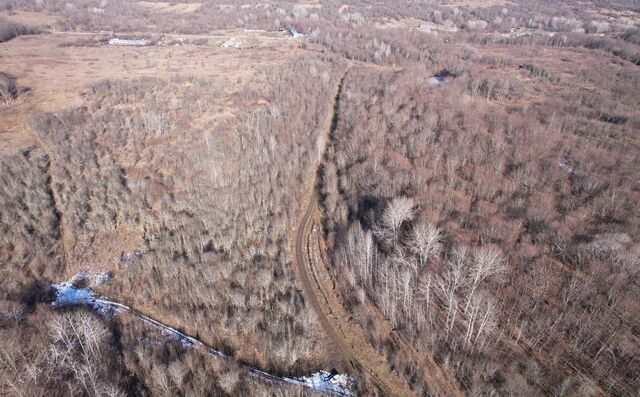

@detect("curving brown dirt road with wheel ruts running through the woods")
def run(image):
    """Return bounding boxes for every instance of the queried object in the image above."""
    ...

[294,66,415,396]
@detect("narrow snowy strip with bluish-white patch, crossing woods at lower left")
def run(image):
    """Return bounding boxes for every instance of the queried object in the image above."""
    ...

[52,272,355,396]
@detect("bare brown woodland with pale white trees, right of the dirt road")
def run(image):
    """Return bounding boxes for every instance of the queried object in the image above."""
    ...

[321,34,640,395]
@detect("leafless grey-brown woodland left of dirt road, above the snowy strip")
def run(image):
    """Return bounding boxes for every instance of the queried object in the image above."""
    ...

[1,52,339,395]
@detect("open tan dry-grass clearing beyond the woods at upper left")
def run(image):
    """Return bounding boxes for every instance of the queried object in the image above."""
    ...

[0,29,297,155]
